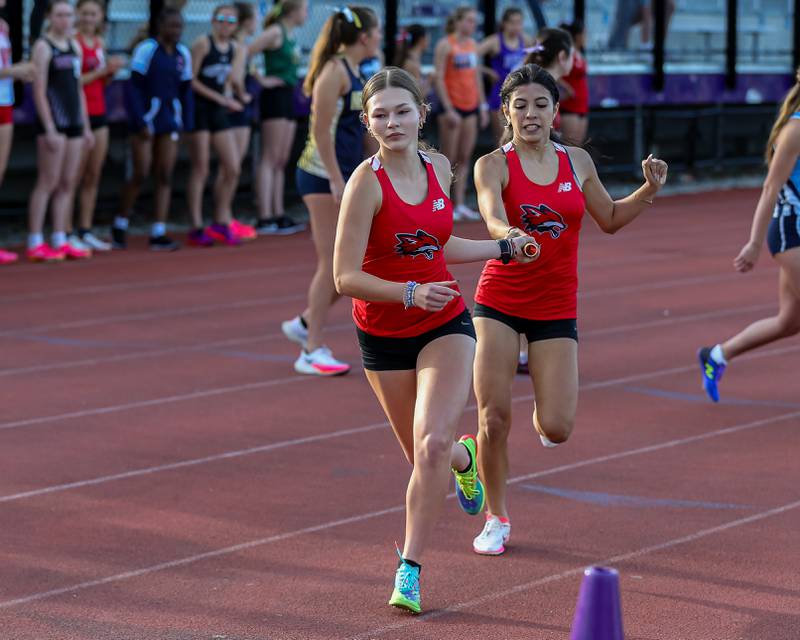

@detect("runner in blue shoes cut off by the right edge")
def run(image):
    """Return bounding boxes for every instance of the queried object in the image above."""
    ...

[698,69,800,402]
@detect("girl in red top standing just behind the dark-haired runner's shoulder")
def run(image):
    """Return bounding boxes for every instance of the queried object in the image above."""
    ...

[559,20,589,147]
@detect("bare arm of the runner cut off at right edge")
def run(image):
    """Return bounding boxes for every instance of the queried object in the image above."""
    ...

[733,120,800,272]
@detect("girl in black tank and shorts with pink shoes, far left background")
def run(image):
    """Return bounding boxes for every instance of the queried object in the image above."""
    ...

[27,0,94,262]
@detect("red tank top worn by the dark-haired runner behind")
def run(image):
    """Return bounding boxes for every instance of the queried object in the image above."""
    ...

[475,143,586,320]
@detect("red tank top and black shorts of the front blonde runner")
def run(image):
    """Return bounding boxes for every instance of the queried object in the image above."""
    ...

[353,153,475,371]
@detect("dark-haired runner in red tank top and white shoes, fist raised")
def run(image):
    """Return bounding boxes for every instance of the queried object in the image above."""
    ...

[473,64,667,555]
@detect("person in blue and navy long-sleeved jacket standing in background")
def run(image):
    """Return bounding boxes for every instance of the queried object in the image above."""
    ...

[111,8,194,251]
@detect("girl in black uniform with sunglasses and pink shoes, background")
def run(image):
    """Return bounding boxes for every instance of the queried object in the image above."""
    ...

[186,4,255,247]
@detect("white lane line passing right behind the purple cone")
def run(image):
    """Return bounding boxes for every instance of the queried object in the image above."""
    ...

[350,500,800,640]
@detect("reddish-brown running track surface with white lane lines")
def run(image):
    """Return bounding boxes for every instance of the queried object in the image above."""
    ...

[0,191,800,640]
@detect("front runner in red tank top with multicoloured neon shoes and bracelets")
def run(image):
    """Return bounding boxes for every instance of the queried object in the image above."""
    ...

[334,67,534,613]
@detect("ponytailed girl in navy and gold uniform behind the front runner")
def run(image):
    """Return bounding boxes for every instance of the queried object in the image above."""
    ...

[281,7,381,376]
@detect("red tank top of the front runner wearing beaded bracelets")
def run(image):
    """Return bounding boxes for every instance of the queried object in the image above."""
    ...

[353,153,466,338]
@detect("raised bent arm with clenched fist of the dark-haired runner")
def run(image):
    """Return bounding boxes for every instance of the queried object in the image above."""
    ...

[569,147,667,233]
